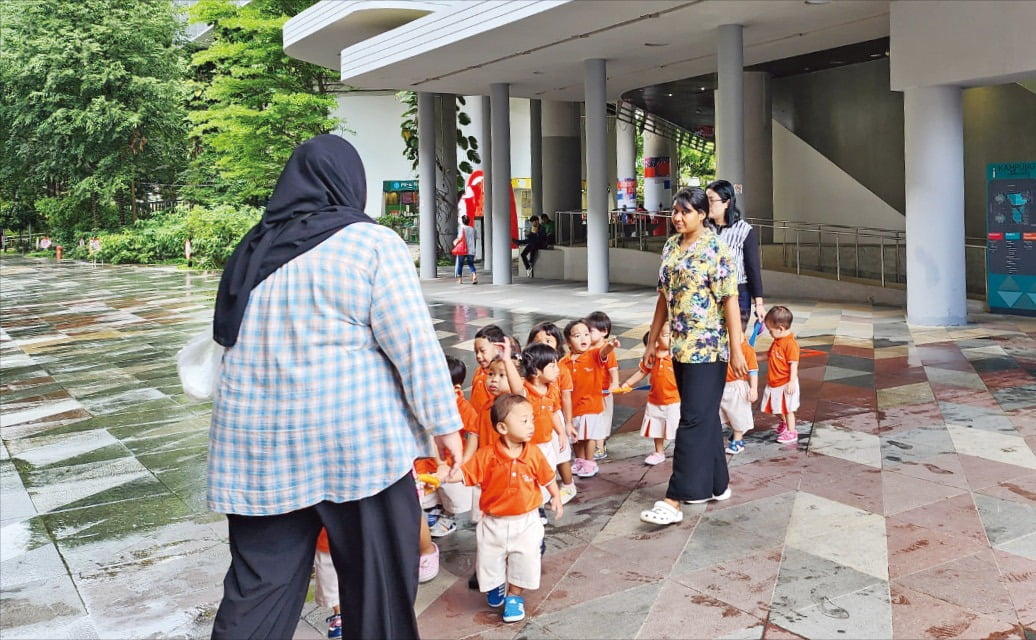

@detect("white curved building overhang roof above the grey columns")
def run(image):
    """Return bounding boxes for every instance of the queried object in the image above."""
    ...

[284,0,889,100]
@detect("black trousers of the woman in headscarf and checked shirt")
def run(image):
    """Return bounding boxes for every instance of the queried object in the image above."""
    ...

[212,473,422,640]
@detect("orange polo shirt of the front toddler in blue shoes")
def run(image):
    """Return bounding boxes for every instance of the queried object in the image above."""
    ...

[463,439,554,517]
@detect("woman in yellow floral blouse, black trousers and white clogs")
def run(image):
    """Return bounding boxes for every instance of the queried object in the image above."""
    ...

[640,186,748,524]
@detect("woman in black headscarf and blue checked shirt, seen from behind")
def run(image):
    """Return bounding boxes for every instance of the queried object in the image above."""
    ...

[207,135,461,639]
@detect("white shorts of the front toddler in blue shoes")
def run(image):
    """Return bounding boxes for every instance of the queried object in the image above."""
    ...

[474,511,543,592]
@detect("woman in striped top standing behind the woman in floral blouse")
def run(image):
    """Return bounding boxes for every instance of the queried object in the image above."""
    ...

[706,180,766,328]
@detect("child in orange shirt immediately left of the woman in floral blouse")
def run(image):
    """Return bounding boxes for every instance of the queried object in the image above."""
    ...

[622,322,680,465]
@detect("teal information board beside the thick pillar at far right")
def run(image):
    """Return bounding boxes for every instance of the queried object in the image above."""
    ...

[985,163,1036,316]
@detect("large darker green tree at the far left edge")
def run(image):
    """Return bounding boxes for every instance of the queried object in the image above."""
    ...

[0,0,185,235]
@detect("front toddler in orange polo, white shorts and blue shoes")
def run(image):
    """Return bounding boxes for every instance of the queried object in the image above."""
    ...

[463,394,564,622]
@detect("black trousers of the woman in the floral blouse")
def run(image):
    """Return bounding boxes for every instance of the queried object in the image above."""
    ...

[665,361,730,500]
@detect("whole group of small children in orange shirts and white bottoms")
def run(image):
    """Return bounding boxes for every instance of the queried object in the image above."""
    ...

[306,307,799,638]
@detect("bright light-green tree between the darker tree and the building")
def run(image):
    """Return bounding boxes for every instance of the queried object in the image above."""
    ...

[184,0,338,203]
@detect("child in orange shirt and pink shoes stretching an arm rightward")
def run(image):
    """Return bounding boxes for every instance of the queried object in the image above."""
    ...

[562,320,618,477]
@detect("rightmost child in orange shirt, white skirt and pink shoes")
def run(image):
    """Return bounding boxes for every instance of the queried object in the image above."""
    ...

[759,306,799,444]
